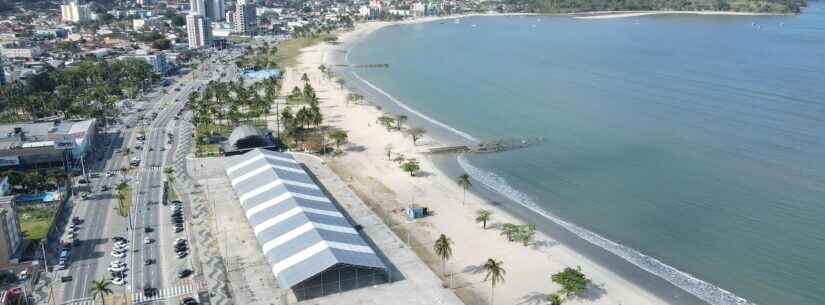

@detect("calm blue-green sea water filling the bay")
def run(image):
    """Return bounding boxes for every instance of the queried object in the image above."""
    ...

[346,2,825,305]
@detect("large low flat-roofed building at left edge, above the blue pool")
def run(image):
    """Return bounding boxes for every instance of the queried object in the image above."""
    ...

[0,119,96,170]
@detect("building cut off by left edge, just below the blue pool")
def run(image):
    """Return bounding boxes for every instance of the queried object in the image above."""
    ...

[0,196,23,266]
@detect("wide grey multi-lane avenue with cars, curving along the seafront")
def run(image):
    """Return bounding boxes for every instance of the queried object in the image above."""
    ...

[52,52,237,304]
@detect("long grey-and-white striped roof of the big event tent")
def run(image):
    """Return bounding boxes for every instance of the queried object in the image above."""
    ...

[225,149,386,288]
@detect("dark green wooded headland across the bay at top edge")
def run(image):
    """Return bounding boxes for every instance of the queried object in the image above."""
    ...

[507,0,806,13]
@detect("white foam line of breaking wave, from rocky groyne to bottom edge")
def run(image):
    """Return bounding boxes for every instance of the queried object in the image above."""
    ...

[458,155,756,305]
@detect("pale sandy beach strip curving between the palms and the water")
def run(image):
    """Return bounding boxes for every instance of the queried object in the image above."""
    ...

[271,17,667,305]
